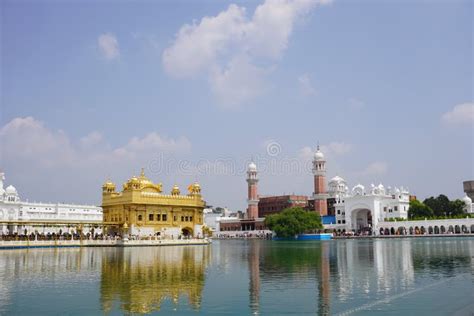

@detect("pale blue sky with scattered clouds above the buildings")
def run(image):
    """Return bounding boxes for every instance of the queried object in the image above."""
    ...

[0,0,474,210]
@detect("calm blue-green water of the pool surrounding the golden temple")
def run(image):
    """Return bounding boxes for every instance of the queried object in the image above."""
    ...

[0,237,474,315]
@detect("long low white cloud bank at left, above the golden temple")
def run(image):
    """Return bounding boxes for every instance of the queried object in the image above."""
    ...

[0,117,191,168]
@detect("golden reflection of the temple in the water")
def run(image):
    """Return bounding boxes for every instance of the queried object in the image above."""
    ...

[100,246,210,313]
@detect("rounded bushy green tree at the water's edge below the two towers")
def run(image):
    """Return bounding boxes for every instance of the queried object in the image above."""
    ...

[265,207,323,238]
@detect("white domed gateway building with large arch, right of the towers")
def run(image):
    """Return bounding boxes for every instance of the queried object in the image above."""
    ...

[328,177,410,232]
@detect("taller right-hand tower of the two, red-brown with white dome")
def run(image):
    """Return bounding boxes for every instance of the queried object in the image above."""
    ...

[313,145,328,216]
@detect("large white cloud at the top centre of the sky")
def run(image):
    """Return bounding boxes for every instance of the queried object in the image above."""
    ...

[162,0,329,105]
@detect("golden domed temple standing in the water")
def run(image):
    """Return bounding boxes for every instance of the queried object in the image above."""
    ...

[102,169,205,237]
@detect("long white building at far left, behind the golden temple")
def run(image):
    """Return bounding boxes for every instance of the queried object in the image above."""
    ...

[0,172,102,235]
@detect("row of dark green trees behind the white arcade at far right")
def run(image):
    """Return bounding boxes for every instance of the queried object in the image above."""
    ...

[408,194,466,219]
